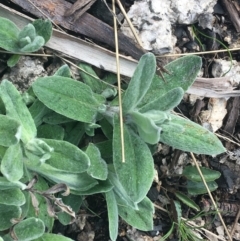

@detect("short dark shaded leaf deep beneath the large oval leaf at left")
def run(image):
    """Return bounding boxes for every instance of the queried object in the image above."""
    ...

[37,124,64,140]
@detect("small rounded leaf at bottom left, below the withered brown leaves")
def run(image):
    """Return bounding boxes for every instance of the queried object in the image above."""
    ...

[13,218,45,241]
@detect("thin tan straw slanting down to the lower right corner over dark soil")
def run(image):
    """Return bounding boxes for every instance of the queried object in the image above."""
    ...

[191,152,232,241]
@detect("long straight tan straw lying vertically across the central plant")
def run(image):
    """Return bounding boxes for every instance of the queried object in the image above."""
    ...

[112,0,125,162]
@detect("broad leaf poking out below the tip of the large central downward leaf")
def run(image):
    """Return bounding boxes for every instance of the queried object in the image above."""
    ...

[118,197,154,231]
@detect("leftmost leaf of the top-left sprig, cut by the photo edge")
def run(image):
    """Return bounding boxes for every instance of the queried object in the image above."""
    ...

[0,18,20,52]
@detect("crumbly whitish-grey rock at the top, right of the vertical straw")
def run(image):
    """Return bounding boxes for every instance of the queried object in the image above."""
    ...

[121,0,217,54]
